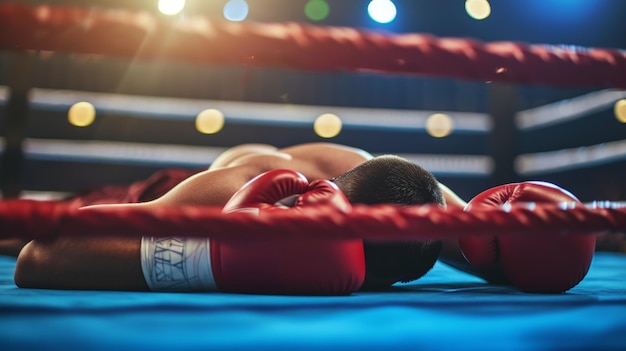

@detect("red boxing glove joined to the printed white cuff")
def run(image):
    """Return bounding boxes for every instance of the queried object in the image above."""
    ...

[217,170,365,295]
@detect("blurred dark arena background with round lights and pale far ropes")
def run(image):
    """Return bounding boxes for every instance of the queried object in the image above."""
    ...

[0,0,626,201]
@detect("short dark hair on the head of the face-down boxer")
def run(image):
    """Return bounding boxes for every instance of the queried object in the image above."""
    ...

[334,155,445,289]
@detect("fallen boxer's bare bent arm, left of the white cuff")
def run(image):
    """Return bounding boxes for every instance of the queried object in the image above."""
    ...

[14,167,256,290]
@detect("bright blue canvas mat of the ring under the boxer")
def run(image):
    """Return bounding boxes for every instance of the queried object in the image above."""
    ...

[0,253,626,350]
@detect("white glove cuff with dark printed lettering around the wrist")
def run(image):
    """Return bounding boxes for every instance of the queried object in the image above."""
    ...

[141,236,217,291]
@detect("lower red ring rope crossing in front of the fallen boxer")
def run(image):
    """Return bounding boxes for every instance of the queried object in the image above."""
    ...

[0,200,626,241]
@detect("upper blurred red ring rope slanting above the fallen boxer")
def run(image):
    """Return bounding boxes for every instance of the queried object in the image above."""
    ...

[0,4,626,88]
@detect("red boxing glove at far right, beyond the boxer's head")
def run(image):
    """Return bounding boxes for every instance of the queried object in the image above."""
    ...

[459,182,595,293]
